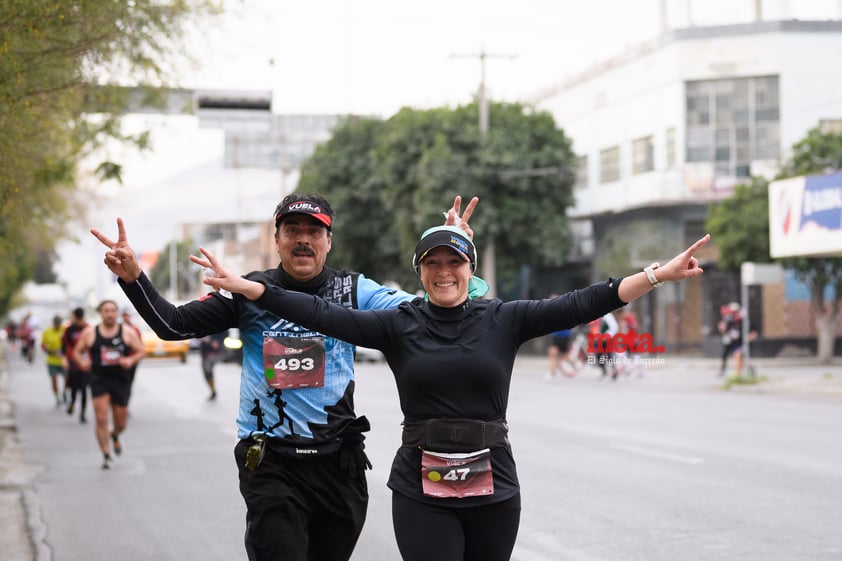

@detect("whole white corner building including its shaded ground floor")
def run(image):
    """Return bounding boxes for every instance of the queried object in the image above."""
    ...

[533,20,842,352]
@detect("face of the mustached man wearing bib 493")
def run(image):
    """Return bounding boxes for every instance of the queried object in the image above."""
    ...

[275,214,332,282]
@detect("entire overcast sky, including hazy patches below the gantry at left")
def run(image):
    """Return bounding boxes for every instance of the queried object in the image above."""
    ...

[57,0,842,302]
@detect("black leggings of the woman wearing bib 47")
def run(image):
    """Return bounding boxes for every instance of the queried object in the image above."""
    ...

[392,492,520,561]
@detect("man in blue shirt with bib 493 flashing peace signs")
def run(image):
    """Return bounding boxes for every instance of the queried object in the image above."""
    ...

[91,193,478,561]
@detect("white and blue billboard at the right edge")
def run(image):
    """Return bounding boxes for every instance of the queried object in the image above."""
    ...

[769,172,842,259]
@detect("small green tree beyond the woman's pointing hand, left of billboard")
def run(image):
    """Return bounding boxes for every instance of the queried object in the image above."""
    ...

[705,177,771,271]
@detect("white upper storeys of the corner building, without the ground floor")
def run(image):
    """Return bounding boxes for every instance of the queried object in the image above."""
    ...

[540,21,842,216]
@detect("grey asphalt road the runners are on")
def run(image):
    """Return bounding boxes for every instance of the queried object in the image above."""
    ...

[0,348,842,561]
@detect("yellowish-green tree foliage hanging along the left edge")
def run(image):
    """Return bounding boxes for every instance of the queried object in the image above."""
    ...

[0,0,219,315]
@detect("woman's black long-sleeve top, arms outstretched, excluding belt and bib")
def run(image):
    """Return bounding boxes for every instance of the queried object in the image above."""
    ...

[256,279,625,506]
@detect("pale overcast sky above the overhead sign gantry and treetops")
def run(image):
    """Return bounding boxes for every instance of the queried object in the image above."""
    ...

[177,0,842,116]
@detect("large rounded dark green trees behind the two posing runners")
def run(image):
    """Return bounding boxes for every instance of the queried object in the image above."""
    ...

[297,103,575,290]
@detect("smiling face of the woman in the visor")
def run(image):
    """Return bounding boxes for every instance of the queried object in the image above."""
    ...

[420,247,473,308]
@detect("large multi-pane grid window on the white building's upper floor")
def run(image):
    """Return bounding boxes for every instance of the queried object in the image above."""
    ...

[685,76,780,177]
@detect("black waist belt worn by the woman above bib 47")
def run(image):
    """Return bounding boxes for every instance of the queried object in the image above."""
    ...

[402,419,509,452]
